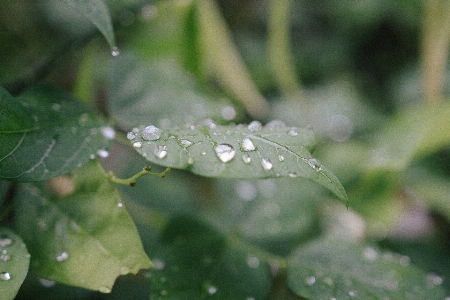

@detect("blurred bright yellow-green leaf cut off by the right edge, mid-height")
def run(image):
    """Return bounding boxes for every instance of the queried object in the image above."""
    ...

[369,101,450,171]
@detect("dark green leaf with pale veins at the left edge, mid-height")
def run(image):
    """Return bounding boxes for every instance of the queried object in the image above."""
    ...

[0,87,115,182]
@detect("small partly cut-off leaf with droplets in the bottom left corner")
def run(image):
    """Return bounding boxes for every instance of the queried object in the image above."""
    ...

[0,227,30,300]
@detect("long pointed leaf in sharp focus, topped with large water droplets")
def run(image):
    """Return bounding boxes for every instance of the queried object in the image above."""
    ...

[128,120,347,202]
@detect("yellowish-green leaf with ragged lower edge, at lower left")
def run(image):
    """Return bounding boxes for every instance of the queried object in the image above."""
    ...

[16,161,151,292]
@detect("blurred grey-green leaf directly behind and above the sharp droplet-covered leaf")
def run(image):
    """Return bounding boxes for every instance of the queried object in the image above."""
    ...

[109,53,241,129]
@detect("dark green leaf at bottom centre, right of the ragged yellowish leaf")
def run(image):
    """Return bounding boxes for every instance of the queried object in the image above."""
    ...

[149,217,270,299]
